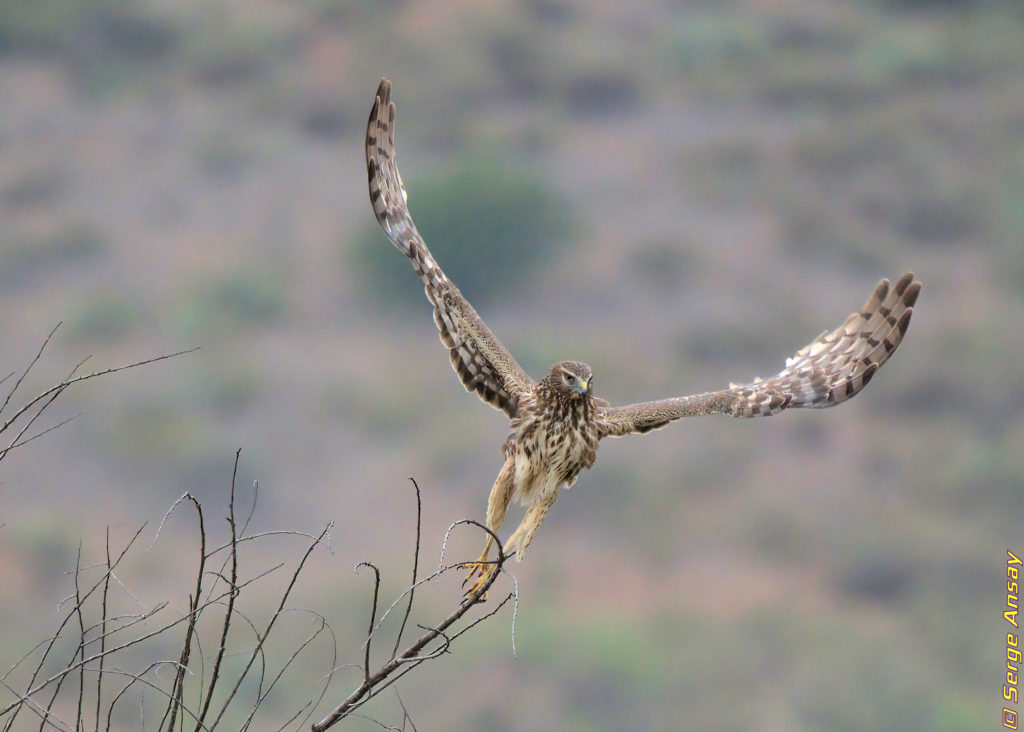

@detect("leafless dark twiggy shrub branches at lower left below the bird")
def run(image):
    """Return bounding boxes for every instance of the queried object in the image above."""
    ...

[0,329,517,732]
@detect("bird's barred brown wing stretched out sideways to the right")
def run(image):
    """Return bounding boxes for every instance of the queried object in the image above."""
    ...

[597,272,921,437]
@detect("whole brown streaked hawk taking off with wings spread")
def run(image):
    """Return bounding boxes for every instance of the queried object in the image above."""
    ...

[367,79,921,597]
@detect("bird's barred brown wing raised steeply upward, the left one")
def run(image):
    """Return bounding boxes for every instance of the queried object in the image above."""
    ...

[367,79,535,417]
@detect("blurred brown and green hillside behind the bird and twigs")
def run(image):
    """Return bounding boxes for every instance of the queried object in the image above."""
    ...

[0,0,1024,732]
